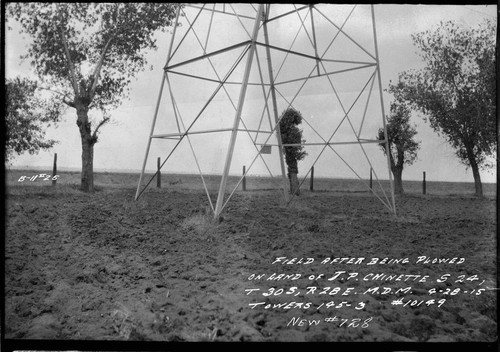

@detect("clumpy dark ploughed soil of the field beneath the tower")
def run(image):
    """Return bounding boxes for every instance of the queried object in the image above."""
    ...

[5,187,497,342]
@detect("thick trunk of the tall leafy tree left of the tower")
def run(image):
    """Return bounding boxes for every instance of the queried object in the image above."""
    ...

[76,105,95,193]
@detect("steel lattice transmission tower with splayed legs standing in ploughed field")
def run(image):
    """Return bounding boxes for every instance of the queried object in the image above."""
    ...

[135,4,396,217]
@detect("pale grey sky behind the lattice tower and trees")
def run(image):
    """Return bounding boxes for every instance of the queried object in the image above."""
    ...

[5,4,497,182]
